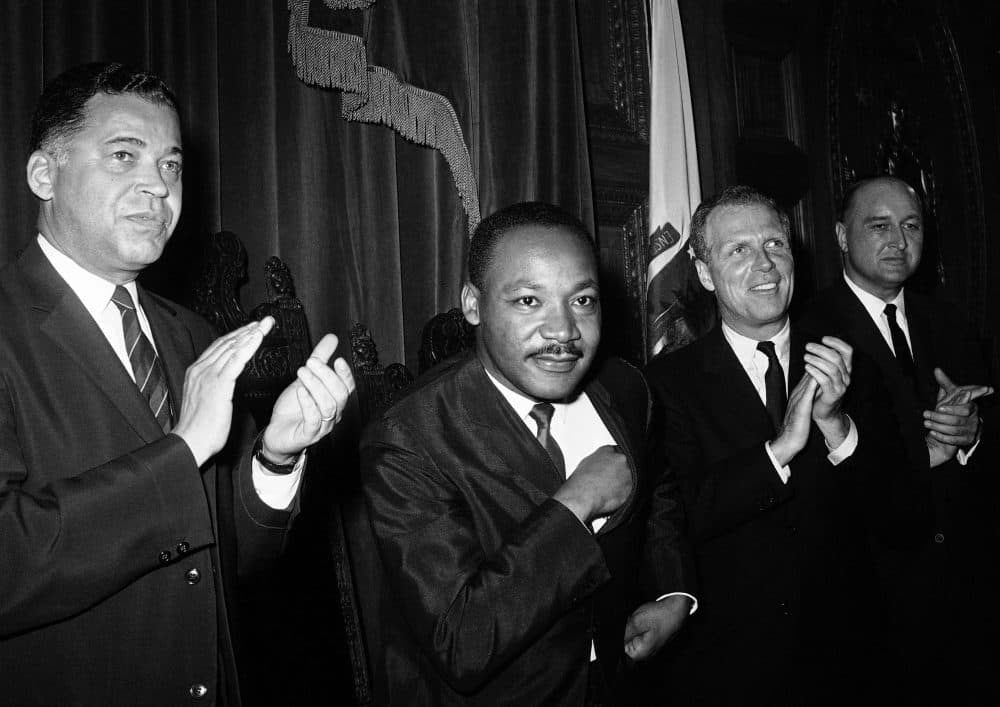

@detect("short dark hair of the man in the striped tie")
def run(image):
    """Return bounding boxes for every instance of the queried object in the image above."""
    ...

[28,62,180,155]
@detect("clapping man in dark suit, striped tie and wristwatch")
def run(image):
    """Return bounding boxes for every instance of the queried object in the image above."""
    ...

[0,64,353,705]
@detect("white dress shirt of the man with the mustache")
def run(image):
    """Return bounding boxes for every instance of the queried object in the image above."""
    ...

[484,369,698,660]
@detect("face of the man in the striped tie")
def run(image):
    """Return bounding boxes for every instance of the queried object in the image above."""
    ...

[28,94,182,283]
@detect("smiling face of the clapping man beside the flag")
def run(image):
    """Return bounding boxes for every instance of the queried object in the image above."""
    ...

[695,204,795,341]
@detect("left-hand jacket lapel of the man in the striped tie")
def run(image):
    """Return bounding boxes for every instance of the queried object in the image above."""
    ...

[21,243,163,442]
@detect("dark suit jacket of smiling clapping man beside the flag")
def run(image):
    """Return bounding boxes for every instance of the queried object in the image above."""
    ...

[646,326,898,705]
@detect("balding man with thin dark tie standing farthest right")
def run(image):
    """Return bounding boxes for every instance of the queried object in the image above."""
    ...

[804,177,1000,704]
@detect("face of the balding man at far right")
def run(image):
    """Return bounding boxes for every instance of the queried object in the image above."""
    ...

[837,180,924,301]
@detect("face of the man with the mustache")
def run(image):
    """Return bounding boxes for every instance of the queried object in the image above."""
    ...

[462,226,601,401]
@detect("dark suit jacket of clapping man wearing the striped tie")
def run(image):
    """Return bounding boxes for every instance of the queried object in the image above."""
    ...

[0,243,290,706]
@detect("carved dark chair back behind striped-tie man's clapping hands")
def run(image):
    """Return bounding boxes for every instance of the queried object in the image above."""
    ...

[190,231,312,425]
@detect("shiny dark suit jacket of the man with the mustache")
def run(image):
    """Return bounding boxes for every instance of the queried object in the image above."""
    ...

[361,356,690,706]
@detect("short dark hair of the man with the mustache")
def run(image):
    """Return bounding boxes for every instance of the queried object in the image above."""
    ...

[468,201,597,290]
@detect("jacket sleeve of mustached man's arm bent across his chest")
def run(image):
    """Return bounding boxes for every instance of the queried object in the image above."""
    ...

[361,419,610,691]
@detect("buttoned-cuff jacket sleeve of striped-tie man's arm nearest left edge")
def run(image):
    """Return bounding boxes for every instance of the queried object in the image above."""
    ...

[0,382,214,635]
